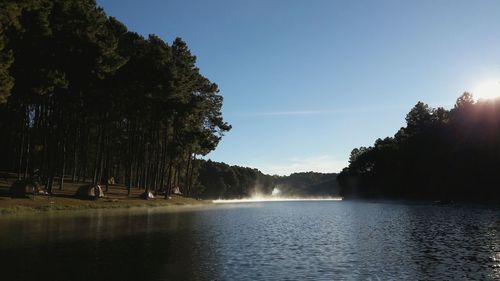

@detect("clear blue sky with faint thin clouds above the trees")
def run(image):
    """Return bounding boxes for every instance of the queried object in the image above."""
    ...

[97,0,500,174]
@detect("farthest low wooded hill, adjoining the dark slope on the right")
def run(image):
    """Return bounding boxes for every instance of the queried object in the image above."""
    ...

[276,172,340,197]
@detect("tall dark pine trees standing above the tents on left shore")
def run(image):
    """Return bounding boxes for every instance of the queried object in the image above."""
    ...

[0,0,231,194]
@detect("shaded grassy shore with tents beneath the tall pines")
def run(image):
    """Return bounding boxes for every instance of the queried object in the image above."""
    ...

[0,174,208,214]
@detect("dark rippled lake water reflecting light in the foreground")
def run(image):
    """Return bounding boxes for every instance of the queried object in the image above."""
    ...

[0,202,500,281]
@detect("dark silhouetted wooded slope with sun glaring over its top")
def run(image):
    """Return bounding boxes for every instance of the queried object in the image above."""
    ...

[338,93,500,200]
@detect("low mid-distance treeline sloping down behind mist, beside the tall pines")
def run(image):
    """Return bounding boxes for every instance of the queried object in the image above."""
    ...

[197,160,275,199]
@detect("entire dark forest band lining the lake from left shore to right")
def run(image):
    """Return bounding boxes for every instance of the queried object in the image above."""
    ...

[7,0,490,202]
